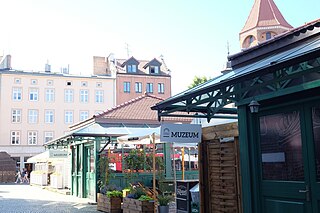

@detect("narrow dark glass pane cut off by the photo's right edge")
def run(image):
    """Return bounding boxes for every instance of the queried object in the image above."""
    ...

[312,107,320,182]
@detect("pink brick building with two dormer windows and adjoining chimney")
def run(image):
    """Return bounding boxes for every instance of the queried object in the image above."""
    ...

[93,54,171,104]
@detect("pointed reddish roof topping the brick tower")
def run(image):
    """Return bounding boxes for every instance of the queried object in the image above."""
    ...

[240,0,292,33]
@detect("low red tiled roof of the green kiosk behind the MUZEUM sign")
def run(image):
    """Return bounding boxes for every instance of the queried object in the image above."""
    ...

[95,93,191,122]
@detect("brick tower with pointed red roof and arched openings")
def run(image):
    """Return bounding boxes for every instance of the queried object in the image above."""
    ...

[239,0,293,49]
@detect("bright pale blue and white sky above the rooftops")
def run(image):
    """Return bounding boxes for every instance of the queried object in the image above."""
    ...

[0,0,320,94]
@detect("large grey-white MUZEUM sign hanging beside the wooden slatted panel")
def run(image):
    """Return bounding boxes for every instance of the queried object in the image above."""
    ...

[160,124,201,143]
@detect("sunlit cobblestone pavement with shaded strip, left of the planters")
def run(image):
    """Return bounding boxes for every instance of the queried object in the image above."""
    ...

[0,183,101,213]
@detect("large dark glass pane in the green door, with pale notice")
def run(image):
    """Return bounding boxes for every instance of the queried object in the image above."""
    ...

[260,111,304,181]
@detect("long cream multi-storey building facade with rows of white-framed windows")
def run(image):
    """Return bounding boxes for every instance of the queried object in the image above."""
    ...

[0,56,116,168]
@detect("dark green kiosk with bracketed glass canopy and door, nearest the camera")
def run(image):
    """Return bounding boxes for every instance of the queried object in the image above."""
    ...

[152,19,320,213]
